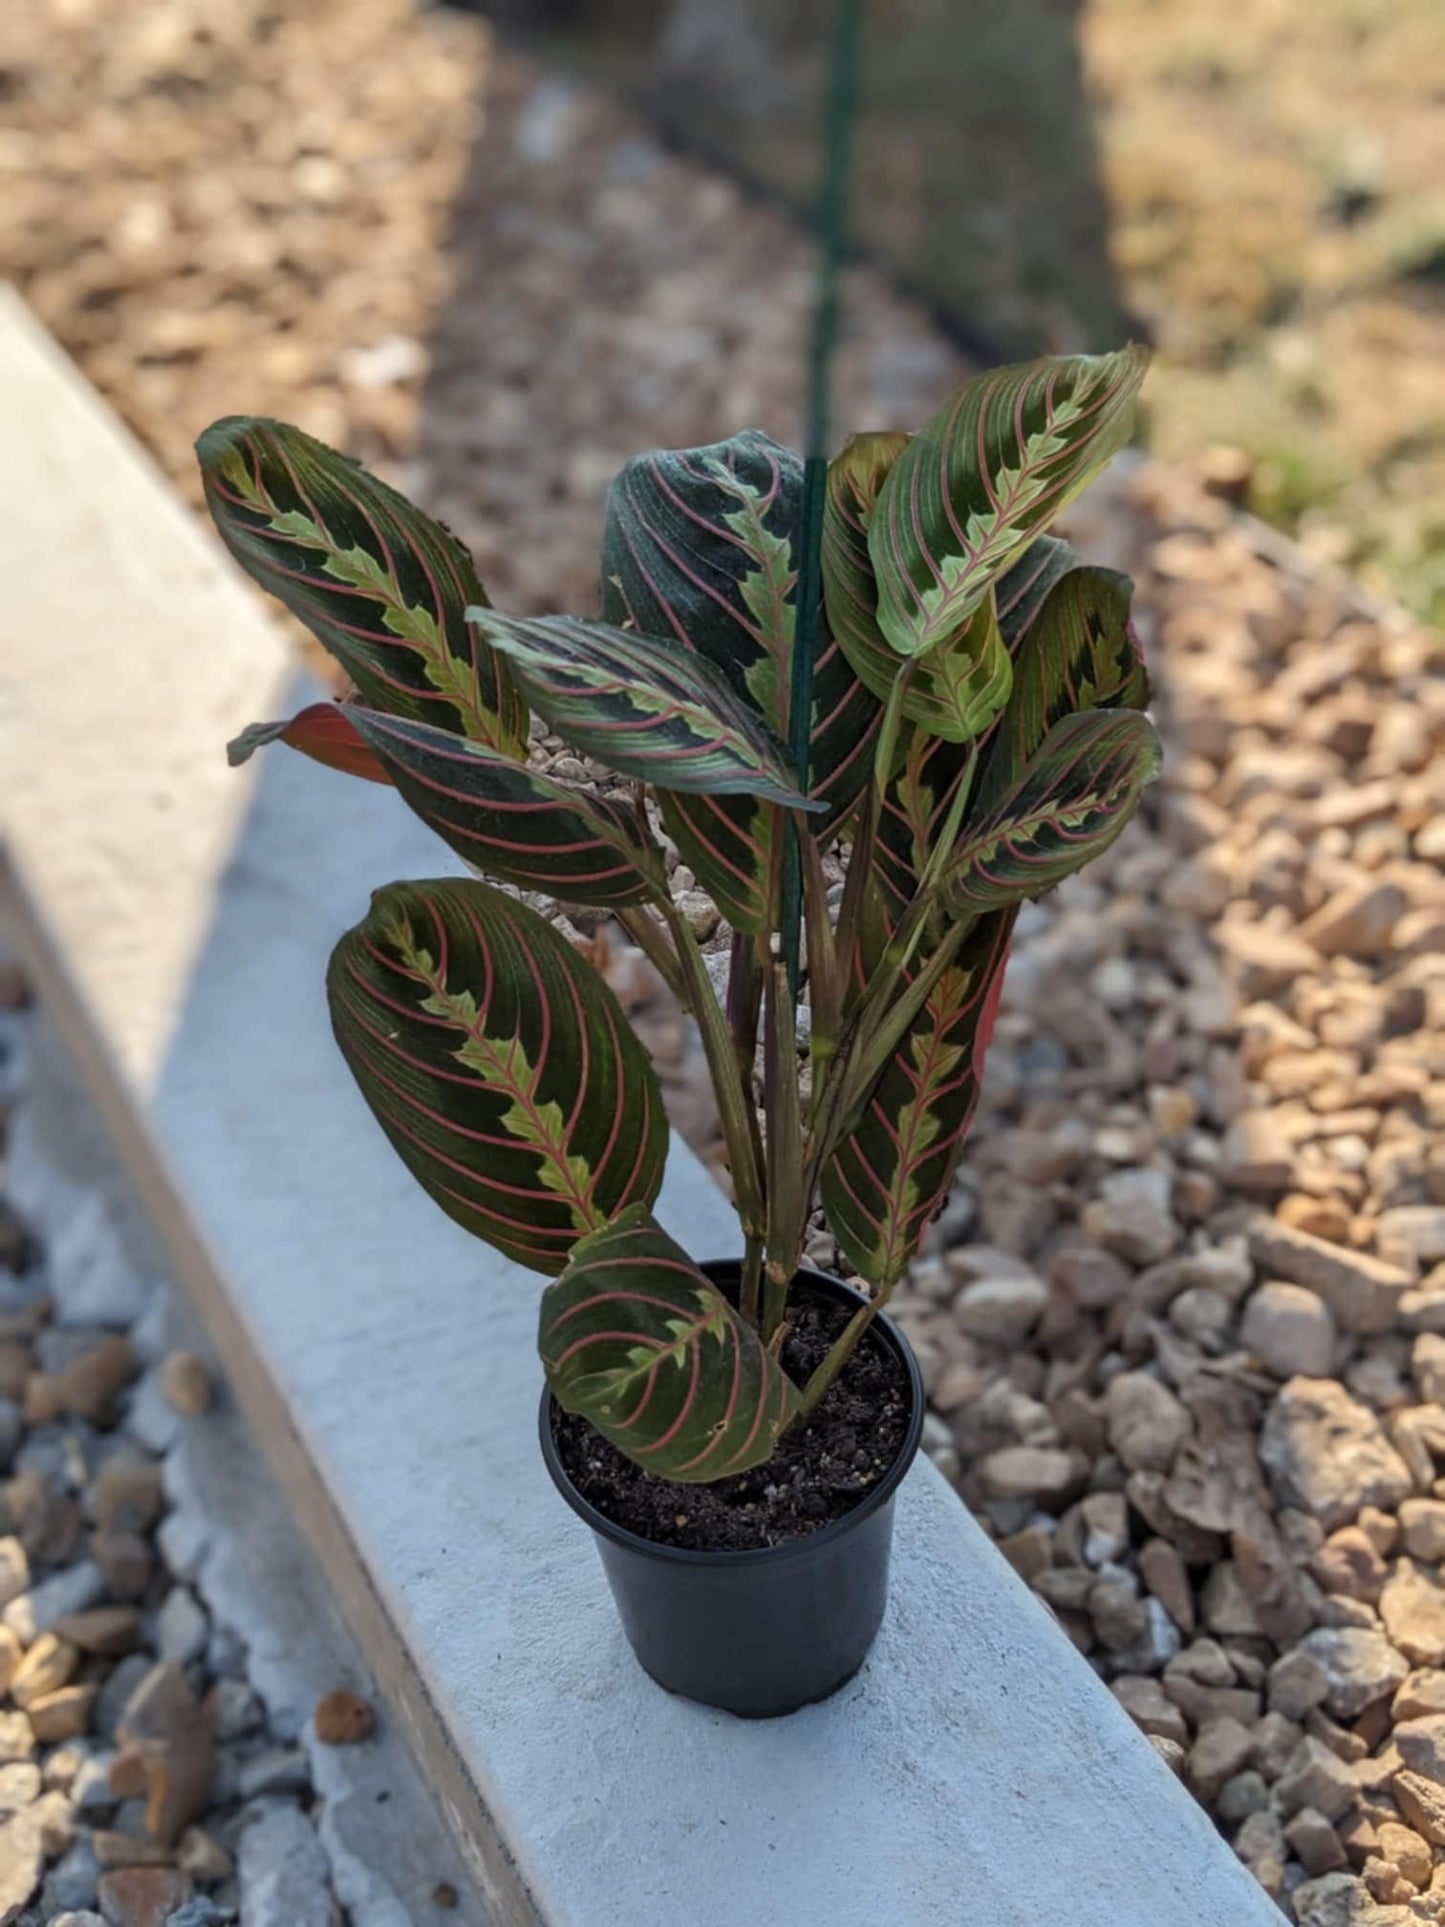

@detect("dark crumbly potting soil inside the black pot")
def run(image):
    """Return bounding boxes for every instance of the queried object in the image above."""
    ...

[551,1291,907,1551]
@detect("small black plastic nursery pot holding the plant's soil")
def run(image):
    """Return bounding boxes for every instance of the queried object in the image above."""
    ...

[541,1260,925,1719]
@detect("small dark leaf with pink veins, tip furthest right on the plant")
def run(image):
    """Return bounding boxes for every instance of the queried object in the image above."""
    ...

[944,709,1160,917]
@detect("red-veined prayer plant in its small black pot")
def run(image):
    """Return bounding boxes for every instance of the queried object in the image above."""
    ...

[198,349,1158,1715]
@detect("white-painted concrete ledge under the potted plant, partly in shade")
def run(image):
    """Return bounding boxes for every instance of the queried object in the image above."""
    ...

[0,289,1279,1927]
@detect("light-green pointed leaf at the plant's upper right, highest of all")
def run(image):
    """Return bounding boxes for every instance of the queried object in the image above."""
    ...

[869,347,1148,657]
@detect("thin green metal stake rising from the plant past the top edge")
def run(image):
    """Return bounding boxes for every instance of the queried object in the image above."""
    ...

[780,0,861,1000]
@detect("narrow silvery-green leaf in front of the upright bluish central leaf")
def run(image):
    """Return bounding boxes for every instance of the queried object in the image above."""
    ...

[470,609,809,809]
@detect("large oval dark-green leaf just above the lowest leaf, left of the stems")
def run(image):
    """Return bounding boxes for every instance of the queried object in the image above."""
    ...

[326,879,667,1274]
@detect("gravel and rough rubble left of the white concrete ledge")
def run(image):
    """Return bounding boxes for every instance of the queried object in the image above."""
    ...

[0,994,478,1927]
